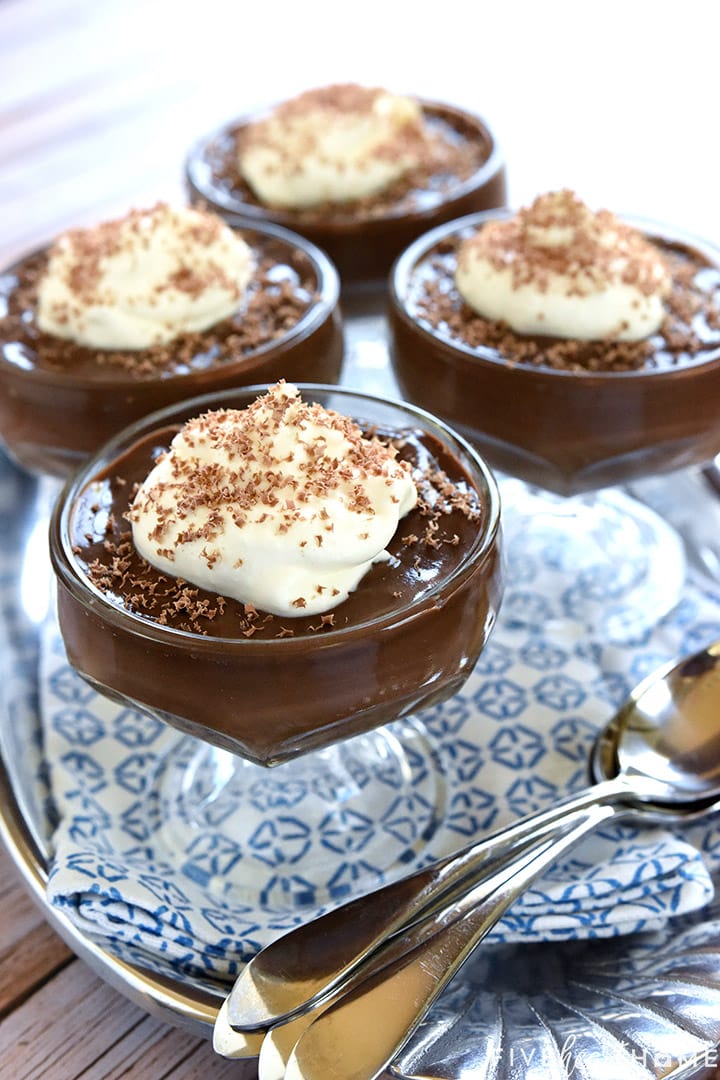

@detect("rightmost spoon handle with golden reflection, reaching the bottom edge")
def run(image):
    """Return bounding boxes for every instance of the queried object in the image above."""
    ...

[284,804,616,1080]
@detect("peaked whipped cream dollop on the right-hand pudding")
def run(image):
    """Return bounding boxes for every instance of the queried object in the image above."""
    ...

[456,191,670,341]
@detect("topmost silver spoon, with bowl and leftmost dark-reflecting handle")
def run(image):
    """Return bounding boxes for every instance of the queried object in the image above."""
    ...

[227,642,720,1049]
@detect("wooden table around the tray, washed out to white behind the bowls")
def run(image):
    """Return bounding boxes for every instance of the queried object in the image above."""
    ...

[0,0,720,1080]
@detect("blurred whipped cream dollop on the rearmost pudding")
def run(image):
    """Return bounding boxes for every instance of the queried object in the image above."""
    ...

[239,83,426,208]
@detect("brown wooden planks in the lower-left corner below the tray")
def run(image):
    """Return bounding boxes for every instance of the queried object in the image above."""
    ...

[0,848,256,1080]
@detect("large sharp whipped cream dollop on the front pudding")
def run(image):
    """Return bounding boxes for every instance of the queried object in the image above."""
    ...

[130,382,418,617]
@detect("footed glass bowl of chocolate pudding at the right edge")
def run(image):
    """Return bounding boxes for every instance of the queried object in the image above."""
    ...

[390,192,720,639]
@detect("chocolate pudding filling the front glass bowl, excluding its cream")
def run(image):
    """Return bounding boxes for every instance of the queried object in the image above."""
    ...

[51,387,501,765]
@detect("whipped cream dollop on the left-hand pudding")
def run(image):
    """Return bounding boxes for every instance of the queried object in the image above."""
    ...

[38,203,253,350]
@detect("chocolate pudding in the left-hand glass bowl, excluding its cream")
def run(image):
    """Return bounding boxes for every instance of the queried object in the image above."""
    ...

[0,220,342,475]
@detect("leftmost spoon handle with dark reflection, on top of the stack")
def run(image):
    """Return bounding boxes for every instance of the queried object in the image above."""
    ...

[228,777,642,1031]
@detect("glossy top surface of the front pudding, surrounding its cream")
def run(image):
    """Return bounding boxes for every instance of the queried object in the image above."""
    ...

[70,428,487,639]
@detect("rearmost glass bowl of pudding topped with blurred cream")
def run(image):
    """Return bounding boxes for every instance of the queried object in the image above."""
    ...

[186,84,506,286]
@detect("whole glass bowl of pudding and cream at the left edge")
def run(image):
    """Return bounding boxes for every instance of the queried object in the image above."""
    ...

[0,204,342,476]
